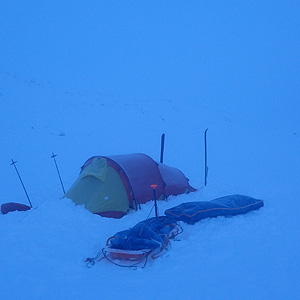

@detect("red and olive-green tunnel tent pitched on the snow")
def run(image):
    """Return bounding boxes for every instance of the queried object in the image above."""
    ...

[64,153,195,218]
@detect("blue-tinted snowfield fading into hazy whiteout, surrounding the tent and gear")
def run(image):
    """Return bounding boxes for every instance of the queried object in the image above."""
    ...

[0,1,300,300]
